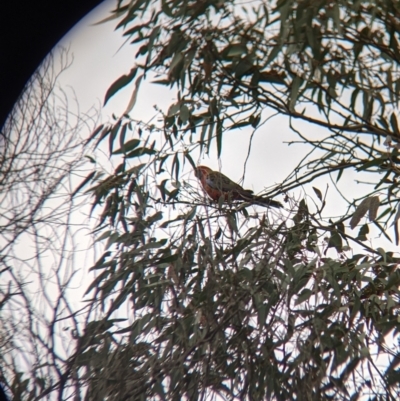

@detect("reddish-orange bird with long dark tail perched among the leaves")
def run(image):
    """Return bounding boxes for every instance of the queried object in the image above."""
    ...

[195,166,282,207]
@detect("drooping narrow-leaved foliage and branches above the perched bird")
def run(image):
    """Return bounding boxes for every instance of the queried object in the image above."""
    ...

[103,0,400,234]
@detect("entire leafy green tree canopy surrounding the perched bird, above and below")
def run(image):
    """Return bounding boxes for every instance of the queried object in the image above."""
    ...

[72,0,400,400]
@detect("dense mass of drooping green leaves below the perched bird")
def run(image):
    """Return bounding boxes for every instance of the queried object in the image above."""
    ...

[77,149,400,400]
